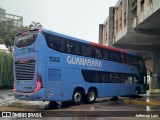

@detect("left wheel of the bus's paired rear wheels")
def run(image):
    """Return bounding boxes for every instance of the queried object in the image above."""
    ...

[72,90,82,105]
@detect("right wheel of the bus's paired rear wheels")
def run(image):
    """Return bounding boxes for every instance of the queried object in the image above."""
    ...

[87,89,96,104]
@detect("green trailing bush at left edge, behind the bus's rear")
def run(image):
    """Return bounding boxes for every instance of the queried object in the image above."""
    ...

[0,52,13,88]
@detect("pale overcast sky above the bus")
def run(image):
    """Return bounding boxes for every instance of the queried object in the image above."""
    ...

[0,0,118,42]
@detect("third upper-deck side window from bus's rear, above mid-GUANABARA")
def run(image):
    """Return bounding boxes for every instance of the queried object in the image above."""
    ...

[81,43,94,57]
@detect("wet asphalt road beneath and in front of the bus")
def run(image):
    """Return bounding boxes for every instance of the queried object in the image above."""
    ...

[0,90,160,120]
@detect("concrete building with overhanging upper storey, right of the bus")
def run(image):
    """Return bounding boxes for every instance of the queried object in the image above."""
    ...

[99,0,160,93]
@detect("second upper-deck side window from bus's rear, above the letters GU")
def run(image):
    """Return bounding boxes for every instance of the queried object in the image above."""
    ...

[66,40,80,55]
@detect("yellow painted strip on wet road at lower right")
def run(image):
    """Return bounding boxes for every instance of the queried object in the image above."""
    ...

[124,100,160,106]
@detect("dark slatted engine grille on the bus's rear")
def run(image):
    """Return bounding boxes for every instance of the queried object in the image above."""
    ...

[15,60,35,80]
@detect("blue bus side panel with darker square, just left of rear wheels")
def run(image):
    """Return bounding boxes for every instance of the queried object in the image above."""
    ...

[46,68,62,101]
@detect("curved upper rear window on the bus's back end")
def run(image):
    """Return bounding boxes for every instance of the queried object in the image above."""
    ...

[15,31,37,48]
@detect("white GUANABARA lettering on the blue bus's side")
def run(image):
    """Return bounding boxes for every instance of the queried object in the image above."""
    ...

[67,56,102,67]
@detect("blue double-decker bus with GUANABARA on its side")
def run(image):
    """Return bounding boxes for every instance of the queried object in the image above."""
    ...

[14,29,147,104]
